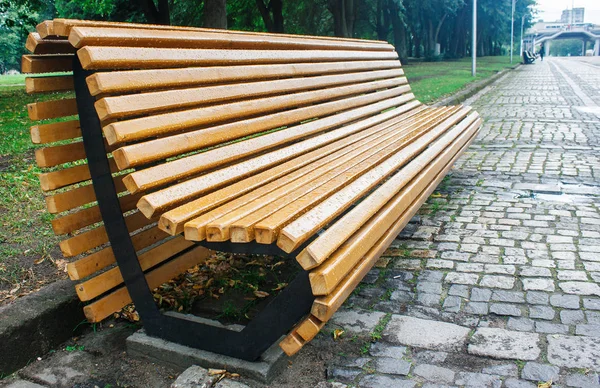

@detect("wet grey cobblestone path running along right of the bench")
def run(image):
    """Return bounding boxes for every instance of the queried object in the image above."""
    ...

[316,58,600,388]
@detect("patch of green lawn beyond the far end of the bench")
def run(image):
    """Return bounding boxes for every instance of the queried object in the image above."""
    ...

[403,56,519,104]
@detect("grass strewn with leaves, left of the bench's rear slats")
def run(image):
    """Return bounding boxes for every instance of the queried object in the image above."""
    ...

[0,75,73,304]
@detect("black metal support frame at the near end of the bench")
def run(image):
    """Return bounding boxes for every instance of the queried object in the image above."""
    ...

[73,55,315,361]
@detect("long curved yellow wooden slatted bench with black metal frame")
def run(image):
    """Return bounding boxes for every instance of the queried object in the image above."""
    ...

[23,19,481,359]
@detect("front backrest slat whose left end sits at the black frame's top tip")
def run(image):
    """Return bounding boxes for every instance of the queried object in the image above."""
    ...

[77,46,398,70]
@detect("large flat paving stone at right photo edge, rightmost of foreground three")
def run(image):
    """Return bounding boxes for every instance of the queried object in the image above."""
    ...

[547,335,600,372]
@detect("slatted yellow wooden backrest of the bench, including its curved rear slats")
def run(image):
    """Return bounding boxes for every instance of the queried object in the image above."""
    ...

[23,19,420,321]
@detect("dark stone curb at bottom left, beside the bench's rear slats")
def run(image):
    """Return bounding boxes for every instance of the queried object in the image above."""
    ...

[0,280,85,377]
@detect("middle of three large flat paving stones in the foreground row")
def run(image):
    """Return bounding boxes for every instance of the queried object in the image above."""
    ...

[472,328,540,360]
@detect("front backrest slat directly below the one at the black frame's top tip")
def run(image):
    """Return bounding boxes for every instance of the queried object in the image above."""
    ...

[86,61,404,96]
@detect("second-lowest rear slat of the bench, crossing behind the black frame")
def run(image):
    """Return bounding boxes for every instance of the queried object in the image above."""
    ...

[75,236,193,302]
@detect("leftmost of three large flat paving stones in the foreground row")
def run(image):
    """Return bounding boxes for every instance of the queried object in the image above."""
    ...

[383,315,469,351]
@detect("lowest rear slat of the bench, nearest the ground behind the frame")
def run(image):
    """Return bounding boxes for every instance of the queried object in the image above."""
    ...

[83,247,210,322]
